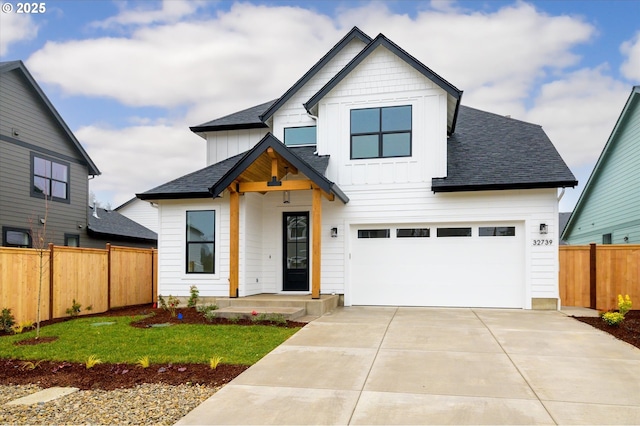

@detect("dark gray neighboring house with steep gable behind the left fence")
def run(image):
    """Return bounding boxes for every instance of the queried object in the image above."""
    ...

[0,61,100,247]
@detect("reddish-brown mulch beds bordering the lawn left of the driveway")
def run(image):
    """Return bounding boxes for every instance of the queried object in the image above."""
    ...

[0,305,306,390]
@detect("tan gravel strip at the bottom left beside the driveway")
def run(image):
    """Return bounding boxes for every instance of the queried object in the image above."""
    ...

[0,384,220,425]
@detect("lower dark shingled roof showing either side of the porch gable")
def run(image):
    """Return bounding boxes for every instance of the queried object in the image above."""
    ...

[136,146,329,200]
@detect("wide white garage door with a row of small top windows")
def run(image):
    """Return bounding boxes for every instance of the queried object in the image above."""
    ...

[350,223,525,308]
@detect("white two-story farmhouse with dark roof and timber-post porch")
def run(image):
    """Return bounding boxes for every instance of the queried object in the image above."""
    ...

[138,28,577,309]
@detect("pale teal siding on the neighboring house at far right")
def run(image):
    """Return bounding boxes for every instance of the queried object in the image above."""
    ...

[567,95,640,244]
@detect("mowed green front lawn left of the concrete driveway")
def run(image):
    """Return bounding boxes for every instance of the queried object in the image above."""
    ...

[0,316,299,365]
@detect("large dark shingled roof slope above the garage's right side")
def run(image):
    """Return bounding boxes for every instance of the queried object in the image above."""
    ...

[432,106,578,192]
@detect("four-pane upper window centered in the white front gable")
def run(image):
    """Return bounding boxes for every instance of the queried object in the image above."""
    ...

[351,105,411,159]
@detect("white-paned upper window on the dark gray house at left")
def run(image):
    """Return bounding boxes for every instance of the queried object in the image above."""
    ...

[31,154,69,203]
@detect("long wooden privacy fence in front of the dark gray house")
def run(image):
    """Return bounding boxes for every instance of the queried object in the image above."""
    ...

[0,244,158,322]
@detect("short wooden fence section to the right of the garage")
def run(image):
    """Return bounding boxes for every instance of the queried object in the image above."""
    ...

[559,244,640,311]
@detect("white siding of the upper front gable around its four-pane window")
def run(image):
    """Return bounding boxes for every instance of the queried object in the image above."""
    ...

[318,46,447,186]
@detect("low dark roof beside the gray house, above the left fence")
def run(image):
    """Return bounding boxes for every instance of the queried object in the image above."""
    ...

[87,207,158,242]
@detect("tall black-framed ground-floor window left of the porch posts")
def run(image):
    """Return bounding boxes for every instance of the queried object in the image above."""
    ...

[186,210,216,274]
